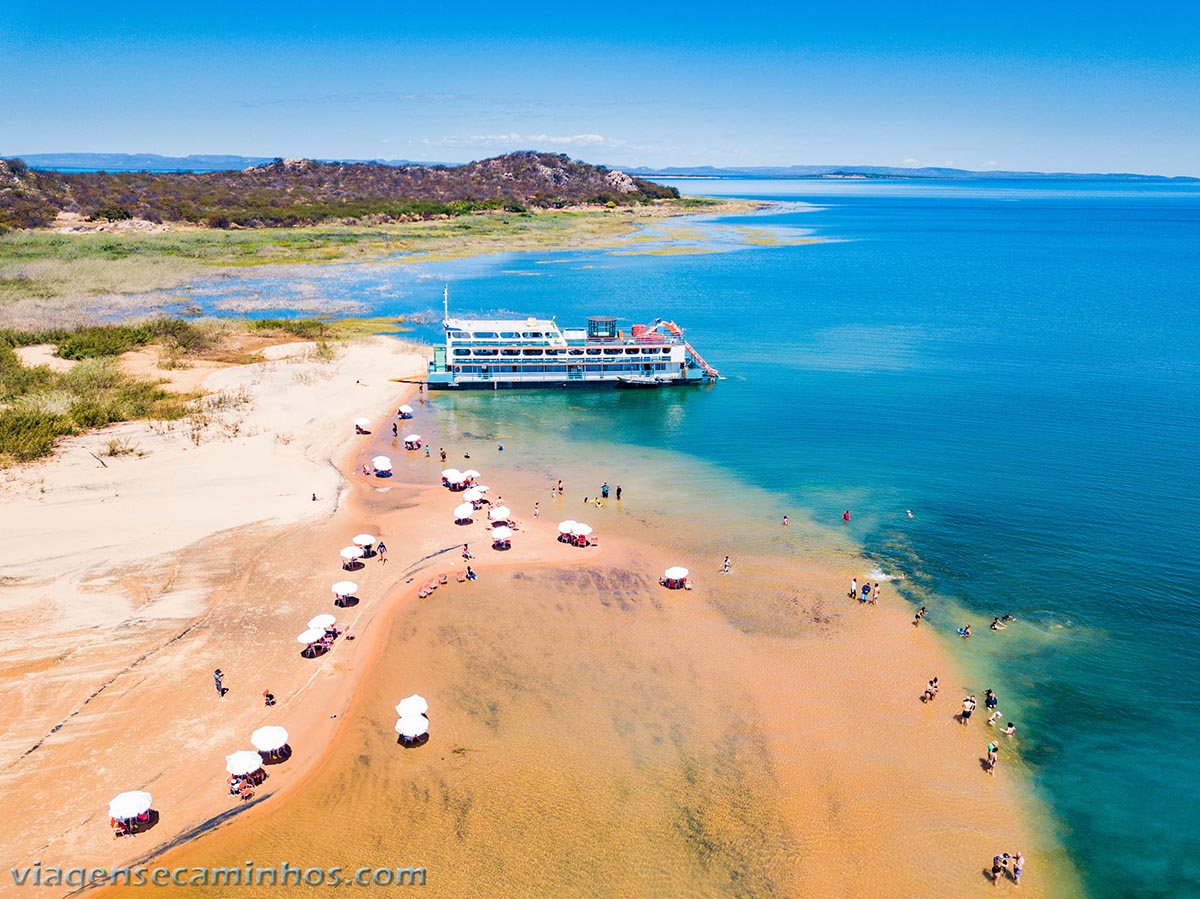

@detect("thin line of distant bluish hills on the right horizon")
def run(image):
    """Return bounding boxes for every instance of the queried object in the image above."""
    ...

[626,166,1200,181]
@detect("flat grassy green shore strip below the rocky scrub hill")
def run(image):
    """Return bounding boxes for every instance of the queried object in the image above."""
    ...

[0,198,770,330]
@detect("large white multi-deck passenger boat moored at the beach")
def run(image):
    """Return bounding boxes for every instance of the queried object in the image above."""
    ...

[428,291,720,390]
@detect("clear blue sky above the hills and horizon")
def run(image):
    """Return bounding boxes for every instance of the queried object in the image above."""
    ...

[0,0,1200,175]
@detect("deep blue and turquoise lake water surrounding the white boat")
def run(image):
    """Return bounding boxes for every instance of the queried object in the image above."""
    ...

[177,181,1200,897]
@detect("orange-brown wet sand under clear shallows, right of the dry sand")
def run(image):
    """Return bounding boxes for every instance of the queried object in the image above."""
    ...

[129,408,1078,897]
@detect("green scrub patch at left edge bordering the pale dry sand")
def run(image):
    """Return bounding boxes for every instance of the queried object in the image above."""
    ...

[0,342,191,466]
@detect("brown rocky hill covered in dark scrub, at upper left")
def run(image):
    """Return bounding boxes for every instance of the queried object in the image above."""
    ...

[0,151,679,230]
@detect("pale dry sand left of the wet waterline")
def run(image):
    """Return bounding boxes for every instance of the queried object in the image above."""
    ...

[0,338,424,894]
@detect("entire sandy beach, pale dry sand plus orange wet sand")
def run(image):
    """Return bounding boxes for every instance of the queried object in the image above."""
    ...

[0,341,1073,897]
